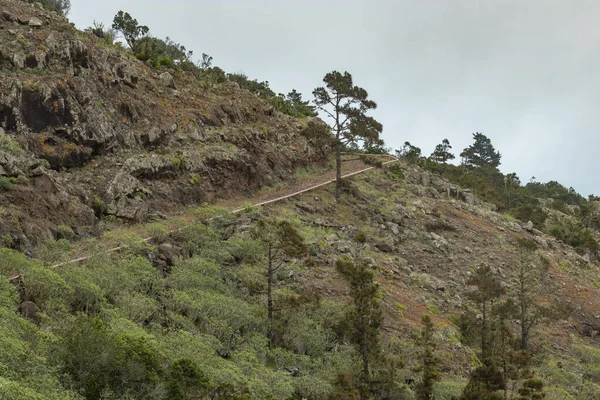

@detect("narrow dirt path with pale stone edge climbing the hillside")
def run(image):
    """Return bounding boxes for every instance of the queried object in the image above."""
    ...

[9,155,398,282]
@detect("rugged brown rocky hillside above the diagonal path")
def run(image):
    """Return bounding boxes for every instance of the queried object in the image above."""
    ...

[0,0,325,249]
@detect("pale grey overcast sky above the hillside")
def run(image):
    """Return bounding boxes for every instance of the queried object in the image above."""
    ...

[69,0,600,196]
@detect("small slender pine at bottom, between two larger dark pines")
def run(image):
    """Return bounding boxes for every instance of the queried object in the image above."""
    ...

[416,315,441,400]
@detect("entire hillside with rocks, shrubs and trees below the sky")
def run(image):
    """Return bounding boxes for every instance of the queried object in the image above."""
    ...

[0,0,600,400]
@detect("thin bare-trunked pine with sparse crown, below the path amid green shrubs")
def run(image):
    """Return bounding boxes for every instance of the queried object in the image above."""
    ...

[253,219,306,348]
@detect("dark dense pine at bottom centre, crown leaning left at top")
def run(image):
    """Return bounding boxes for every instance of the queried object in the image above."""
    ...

[336,258,383,398]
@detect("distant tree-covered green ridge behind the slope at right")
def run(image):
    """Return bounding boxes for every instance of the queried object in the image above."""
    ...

[404,132,600,259]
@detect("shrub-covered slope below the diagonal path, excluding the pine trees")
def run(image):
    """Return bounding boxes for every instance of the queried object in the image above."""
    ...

[0,161,600,400]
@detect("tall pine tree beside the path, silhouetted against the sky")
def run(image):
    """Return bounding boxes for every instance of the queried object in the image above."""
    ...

[313,71,383,199]
